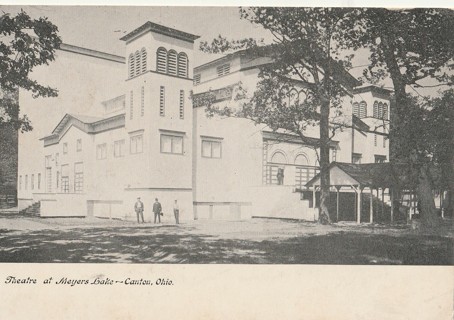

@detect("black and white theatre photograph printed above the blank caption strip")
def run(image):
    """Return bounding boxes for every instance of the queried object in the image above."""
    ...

[0,3,454,319]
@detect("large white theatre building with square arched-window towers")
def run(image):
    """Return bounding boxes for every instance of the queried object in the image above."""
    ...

[18,22,390,220]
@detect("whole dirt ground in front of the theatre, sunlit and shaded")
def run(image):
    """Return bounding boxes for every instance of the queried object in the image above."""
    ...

[0,215,454,265]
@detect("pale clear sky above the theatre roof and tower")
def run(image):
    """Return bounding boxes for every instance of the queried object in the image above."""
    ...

[0,4,454,95]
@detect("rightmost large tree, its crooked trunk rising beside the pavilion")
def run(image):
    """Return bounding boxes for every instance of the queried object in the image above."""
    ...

[341,8,454,226]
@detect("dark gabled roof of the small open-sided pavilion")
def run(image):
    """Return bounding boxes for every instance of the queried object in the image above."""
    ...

[306,162,405,188]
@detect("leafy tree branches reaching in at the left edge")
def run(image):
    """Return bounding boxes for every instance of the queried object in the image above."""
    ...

[0,10,61,131]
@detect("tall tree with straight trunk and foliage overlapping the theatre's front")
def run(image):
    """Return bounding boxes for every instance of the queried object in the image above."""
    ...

[196,7,357,223]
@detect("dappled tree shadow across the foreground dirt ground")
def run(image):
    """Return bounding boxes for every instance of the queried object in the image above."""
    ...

[0,226,454,265]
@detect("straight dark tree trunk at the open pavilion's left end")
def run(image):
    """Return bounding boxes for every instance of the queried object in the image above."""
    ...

[318,99,331,224]
